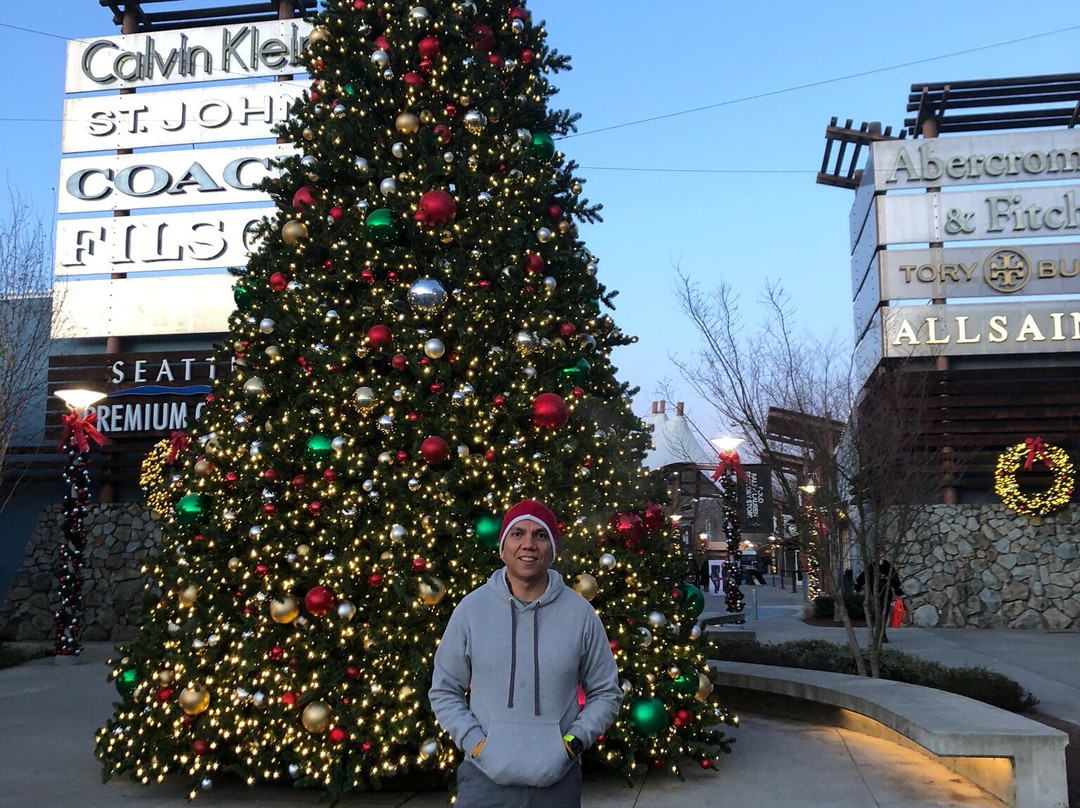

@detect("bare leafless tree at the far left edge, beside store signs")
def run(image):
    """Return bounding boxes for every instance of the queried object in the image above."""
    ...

[0,191,53,510]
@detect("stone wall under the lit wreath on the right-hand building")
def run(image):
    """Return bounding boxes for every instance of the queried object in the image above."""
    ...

[900,506,1080,631]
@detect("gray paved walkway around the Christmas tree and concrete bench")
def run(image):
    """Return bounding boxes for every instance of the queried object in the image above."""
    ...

[0,585,1080,808]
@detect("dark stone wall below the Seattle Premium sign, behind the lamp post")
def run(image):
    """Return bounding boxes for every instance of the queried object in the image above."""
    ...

[0,503,161,642]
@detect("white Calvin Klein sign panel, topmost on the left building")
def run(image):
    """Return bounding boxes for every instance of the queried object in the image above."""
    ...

[64,19,311,93]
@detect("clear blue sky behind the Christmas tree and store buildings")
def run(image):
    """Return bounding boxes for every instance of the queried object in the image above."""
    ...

[0,0,1080,436]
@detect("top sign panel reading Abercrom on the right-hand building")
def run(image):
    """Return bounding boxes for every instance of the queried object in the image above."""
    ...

[867,129,1080,191]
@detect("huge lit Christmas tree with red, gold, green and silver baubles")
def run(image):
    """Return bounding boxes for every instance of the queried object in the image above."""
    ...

[97,0,729,798]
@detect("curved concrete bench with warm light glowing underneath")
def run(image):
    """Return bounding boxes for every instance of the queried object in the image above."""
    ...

[710,661,1068,808]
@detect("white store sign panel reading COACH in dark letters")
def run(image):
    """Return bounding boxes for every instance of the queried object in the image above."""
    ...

[58,144,293,213]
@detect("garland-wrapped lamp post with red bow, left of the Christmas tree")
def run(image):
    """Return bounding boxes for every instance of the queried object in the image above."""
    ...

[53,389,105,658]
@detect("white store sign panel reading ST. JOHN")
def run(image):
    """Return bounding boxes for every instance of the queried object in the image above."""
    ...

[62,82,302,154]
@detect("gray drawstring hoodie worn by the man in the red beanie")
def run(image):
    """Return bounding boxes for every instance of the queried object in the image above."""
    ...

[428,568,622,787]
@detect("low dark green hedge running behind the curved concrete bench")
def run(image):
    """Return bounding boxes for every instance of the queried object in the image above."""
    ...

[710,638,1039,713]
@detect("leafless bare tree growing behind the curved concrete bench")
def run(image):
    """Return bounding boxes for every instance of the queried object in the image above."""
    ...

[674,274,940,676]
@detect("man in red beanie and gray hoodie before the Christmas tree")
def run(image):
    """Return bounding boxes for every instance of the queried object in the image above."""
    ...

[428,499,622,808]
